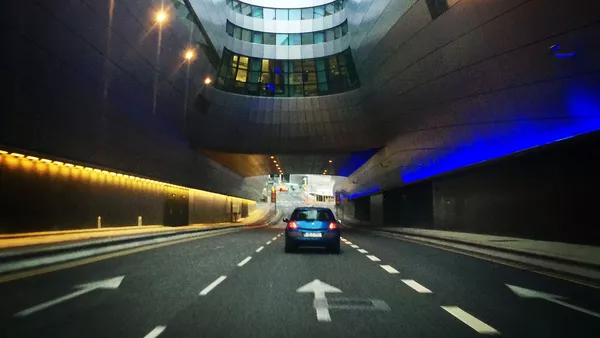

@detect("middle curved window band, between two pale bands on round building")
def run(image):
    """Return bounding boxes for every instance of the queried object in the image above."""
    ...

[226,20,348,46]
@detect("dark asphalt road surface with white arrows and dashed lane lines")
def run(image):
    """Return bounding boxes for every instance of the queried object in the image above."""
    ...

[0,210,600,338]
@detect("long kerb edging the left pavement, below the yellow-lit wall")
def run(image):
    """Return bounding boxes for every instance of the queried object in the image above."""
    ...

[0,211,277,263]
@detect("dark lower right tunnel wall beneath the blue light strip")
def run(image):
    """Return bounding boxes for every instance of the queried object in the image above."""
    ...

[347,132,600,245]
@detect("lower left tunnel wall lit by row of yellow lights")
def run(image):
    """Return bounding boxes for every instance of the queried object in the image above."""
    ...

[0,155,256,233]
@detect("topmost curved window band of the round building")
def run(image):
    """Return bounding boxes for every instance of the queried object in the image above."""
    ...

[227,0,348,20]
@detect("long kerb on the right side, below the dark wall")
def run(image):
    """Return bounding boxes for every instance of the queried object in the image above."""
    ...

[373,228,600,270]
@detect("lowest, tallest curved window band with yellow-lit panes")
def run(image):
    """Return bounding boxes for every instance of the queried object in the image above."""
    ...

[215,48,360,97]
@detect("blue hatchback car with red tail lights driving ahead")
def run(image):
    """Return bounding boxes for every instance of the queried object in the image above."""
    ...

[283,207,340,254]
